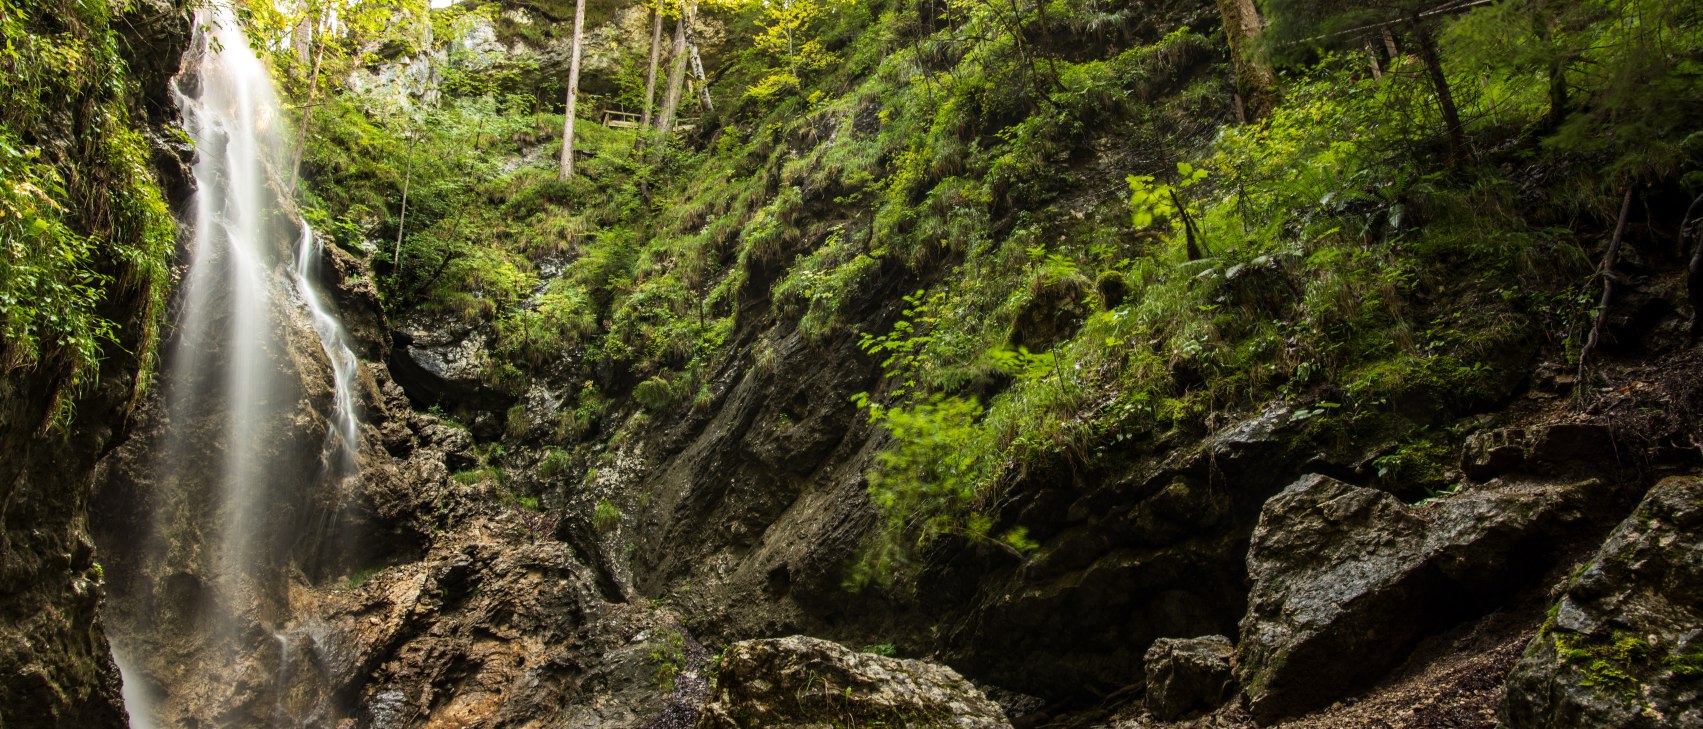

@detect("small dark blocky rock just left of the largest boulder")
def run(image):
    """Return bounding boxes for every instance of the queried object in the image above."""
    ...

[1146,635,1236,720]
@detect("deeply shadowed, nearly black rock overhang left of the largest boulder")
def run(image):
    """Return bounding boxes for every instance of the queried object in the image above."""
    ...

[946,407,1320,703]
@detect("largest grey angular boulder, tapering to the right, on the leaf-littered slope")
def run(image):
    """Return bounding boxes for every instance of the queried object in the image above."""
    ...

[1236,475,1603,720]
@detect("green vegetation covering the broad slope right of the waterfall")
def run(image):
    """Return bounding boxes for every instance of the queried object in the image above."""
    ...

[255,0,1703,584]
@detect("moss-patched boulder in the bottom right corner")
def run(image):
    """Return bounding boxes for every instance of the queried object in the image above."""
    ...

[1500,477,1703,729]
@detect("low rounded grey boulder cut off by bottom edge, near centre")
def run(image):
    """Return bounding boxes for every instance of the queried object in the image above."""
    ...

[697,635,1010,729]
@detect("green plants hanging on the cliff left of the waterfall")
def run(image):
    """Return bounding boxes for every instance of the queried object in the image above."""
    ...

[0,0,175,428]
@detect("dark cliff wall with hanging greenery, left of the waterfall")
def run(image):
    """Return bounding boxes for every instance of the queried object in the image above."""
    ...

[0,0,189,727]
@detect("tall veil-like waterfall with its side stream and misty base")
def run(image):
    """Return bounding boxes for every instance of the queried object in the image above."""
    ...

[112,5,372,727]
